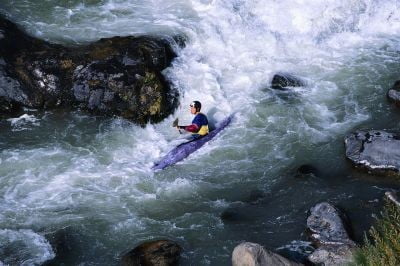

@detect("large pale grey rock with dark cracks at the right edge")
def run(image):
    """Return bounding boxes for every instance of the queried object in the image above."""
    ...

[345,130,400,174]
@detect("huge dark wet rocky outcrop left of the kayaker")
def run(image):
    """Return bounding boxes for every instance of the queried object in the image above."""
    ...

[0,15,177,124]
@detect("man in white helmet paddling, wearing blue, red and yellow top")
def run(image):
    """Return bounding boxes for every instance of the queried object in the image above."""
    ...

[177,101,209,140]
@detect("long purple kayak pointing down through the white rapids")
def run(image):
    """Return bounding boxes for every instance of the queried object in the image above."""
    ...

[152,115,233,170]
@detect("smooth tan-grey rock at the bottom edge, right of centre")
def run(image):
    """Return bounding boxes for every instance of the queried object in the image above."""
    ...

[232,242,302,266]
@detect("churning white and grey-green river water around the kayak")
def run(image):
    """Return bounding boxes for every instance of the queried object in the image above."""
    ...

[0,0,400,265]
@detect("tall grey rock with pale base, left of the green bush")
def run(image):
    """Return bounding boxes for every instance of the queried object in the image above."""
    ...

[307,202,356,265]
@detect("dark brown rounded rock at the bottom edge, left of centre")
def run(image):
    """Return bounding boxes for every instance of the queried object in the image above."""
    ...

[122,240,182,266]
